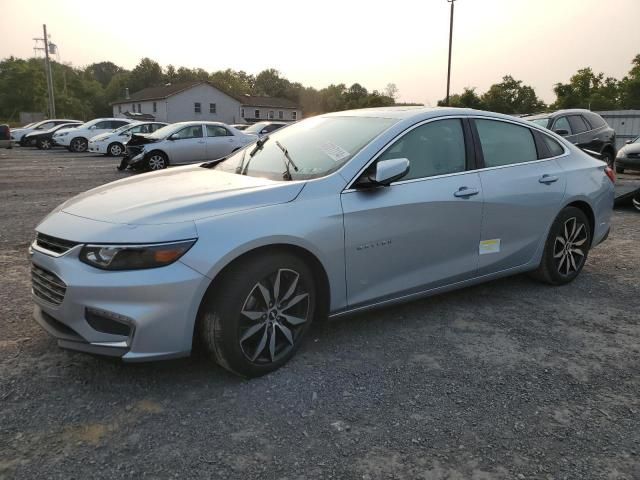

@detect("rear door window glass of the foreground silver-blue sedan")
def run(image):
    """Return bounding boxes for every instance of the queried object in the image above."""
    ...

[475,119,538,167]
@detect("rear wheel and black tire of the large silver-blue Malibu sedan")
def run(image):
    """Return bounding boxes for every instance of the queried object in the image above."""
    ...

[532,207,591,285]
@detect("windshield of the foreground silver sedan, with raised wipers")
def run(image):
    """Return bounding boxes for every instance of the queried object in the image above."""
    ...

[213,117,397,180]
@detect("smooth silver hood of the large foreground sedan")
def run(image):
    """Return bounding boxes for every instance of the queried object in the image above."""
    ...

[58,165,305,225]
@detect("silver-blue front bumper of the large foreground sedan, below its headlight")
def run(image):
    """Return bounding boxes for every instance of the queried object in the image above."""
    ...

[30,240,209,361]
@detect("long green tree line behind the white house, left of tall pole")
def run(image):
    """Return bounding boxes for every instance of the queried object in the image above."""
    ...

[0,57,398,122]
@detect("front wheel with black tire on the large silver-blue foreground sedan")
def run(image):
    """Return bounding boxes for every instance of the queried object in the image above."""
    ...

[198,252,317,377]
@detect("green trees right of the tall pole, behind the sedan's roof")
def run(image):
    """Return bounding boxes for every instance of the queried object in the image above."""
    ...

[438,54,640,114]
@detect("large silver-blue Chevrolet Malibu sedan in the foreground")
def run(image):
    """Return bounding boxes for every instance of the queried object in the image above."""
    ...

[31,108,614,376]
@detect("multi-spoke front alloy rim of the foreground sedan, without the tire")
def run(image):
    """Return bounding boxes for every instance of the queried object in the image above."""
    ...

[238,268,310,364]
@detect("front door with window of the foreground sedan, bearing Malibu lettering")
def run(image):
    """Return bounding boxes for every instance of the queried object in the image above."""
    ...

[342,119,482,307]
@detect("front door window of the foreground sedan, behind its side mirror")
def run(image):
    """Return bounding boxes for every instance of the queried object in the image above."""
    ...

[379,119,466,180]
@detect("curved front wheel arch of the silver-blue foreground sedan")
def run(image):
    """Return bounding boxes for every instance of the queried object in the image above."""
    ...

[193,242,331,345]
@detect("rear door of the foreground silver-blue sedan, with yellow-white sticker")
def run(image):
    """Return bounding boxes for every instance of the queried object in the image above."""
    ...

[474,118,566,275]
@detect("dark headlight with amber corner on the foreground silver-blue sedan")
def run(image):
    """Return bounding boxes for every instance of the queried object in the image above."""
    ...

[80,239,196,270]
